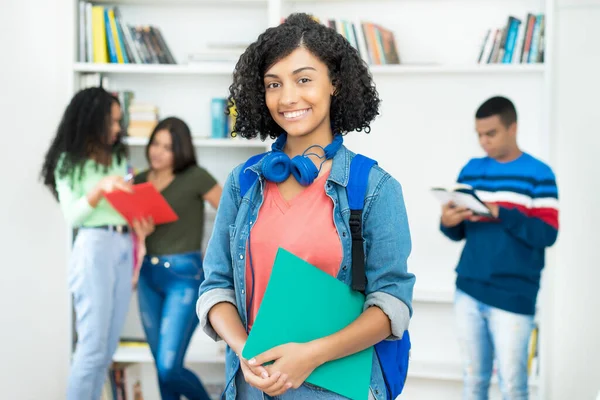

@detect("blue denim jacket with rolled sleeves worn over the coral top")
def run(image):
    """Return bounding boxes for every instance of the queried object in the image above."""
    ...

[196,146,415,400]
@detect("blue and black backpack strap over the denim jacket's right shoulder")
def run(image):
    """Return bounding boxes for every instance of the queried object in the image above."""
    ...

[346,154,377,292]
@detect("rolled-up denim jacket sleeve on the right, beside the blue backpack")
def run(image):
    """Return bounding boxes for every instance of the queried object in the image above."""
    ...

[363,175,415,340]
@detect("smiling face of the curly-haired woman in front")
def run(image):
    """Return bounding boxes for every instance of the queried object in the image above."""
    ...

[264,47,335,137]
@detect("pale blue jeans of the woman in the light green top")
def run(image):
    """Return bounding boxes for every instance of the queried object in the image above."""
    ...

[67,228,133,400]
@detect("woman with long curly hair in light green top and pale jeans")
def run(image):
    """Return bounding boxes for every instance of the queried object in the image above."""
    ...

[42,88,154,400]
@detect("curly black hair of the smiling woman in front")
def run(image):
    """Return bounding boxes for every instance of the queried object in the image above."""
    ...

[226,13,381,140]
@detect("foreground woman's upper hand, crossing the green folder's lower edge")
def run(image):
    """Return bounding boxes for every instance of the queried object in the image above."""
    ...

[248,342,322,396]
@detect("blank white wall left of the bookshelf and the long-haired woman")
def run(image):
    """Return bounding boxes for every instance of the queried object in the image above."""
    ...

[0,0,69,400]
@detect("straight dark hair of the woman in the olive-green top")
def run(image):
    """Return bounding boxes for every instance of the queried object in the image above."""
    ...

[146,117,198,174]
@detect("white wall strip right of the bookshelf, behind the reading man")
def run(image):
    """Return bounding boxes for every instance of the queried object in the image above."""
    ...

[548,0,600,400]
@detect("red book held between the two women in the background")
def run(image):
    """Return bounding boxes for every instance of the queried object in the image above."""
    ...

[104,182,179,225]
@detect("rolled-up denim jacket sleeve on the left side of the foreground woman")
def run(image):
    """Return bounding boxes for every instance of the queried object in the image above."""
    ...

[196,169,240,341]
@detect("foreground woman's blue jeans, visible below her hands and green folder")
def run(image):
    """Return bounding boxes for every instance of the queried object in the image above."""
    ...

[235,369,374,400]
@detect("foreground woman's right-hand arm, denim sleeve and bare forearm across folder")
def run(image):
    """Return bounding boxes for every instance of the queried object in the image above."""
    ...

[320,175,415,350]
